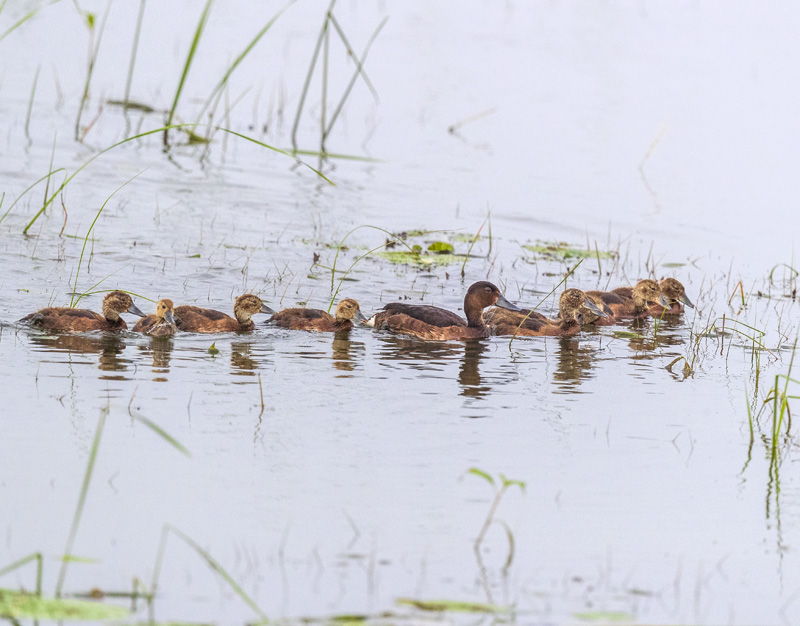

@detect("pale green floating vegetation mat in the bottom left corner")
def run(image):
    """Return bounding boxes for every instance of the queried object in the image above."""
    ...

[0,589,129,621]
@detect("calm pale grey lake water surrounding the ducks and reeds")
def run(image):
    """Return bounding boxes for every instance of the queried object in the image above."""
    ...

[0,0,800,624]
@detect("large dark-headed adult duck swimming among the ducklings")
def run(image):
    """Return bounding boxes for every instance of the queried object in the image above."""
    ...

[367,281,519,341]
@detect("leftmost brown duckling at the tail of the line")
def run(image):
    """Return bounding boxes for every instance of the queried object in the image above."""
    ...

[20,291,144,332]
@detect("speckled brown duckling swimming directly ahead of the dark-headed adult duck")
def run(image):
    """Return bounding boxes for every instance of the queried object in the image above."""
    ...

[491,289,606,337]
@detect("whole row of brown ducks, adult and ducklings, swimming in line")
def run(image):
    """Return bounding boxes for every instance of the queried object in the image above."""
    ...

[20,278,694,341]
